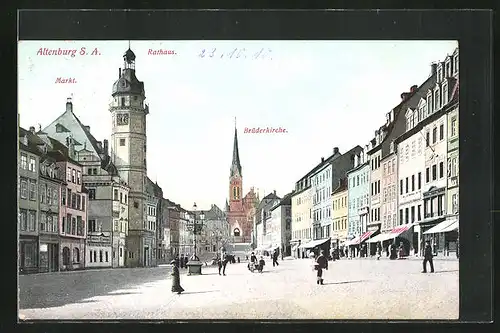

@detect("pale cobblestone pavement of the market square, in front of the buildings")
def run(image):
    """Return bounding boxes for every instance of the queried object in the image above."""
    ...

[19,259,459,320]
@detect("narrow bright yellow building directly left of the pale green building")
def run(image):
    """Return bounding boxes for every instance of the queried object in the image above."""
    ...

[331,179,348,249]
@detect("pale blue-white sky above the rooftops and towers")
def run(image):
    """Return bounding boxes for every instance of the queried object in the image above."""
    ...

[18,41,458,209]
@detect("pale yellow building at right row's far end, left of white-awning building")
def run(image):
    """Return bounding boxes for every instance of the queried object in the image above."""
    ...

[290,177,312,258]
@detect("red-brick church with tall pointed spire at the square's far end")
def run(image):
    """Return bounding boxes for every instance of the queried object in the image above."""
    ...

[226,121,259,244]
